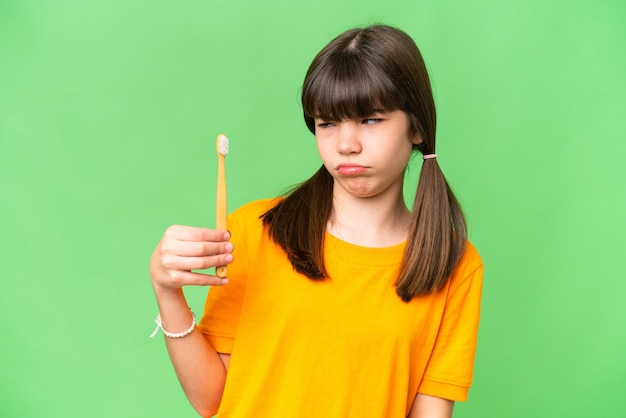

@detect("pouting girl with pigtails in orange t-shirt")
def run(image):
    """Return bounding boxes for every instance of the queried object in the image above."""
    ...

[150,25,483,418]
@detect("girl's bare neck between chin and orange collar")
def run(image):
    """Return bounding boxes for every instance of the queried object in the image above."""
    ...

[326,185,410,248]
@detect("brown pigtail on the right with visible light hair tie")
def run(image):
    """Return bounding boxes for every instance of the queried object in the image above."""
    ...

[396,158,467,302]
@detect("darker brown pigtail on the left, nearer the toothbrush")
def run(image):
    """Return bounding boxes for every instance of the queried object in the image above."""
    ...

[261,166,333,280]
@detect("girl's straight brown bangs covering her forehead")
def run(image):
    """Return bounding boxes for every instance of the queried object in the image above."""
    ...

[302,53,404,122]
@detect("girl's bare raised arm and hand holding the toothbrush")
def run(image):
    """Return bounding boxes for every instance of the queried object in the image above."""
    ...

[150,226,233,416]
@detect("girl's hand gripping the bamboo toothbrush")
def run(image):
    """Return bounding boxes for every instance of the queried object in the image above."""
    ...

[150,225,233,292]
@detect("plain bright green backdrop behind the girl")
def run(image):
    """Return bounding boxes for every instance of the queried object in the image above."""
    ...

[0,0,626,418]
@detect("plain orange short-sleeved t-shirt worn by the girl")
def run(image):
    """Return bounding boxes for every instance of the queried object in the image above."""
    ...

[199,200,483,418]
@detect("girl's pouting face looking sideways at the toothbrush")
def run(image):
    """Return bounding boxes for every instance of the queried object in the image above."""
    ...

[315,110,421,198]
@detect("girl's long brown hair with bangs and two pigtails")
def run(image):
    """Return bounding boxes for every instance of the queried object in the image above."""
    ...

[262,25,467,302]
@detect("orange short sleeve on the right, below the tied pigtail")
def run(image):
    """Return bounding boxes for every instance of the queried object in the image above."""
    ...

[418,244,483,401]
